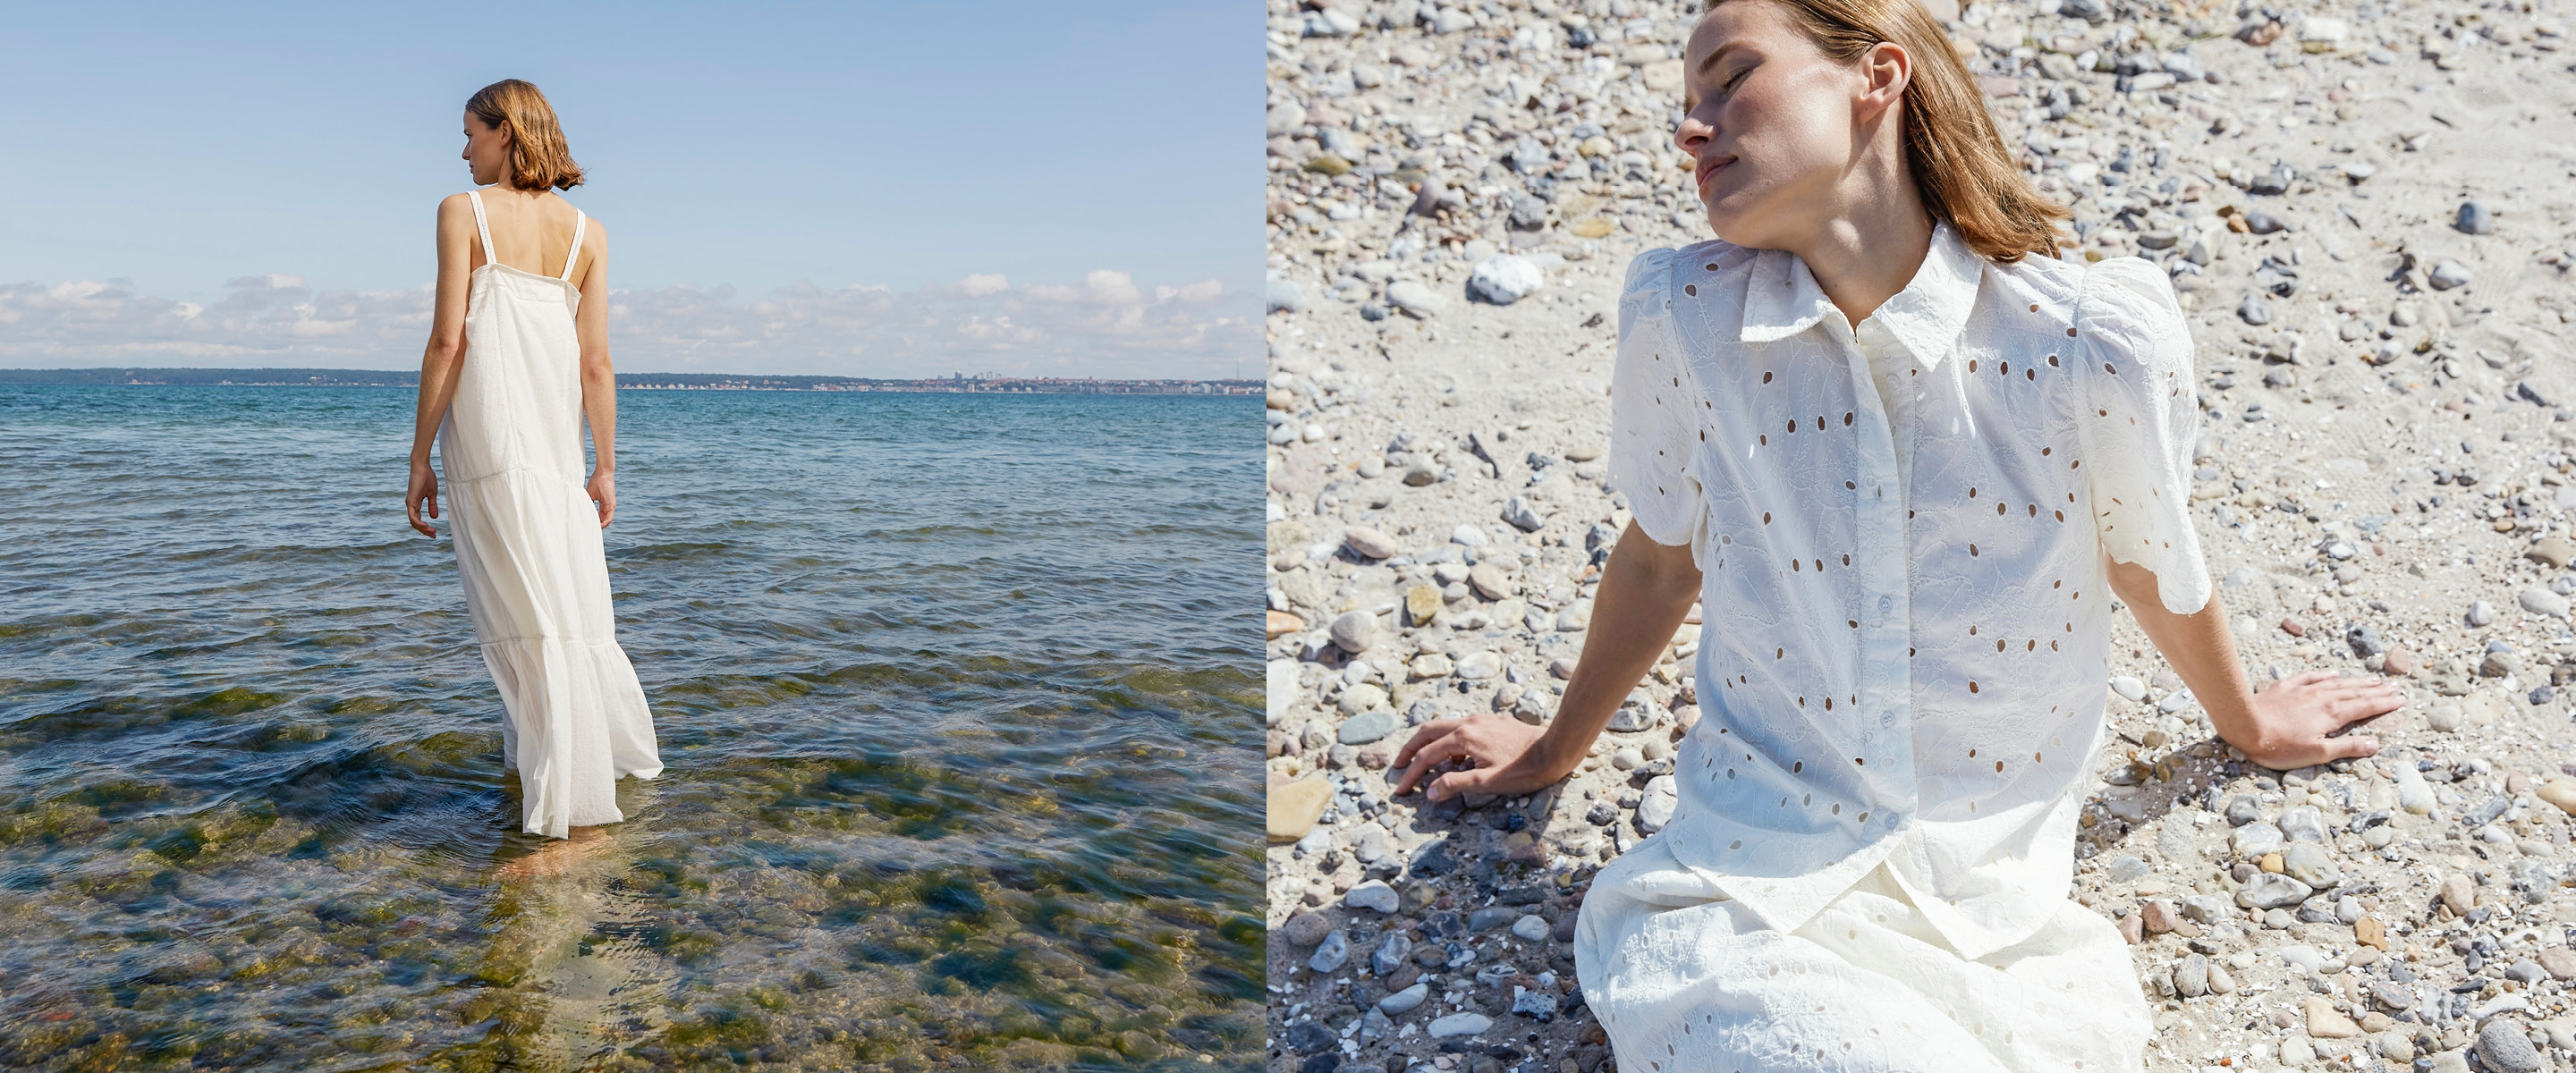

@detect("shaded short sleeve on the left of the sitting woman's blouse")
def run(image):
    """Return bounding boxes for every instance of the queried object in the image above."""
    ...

[1610,249,1703,545]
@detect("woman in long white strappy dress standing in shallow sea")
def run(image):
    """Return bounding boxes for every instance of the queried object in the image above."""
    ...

[404,80,662,839]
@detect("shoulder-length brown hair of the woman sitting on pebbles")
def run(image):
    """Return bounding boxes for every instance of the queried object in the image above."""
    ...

[1703,0,2073,265]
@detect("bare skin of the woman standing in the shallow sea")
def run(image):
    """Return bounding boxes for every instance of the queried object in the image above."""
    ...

[402,114,618,849]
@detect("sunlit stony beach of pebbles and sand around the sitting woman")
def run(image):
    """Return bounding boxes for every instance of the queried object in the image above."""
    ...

[1267,0,2576,1073]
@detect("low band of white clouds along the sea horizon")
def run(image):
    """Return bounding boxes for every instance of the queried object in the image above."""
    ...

[0,267,1262,378]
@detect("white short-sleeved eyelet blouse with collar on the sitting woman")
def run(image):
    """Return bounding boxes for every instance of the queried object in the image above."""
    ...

[1610,224,2210,959]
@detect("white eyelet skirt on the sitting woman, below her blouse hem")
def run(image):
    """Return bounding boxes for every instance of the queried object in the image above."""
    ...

[1574,841,2154,1073]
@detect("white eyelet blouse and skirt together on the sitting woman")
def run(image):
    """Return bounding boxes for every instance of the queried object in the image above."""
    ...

[1574,224,2213,1073]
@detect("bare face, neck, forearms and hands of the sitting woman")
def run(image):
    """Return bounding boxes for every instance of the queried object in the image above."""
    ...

[1394,0,2406,800]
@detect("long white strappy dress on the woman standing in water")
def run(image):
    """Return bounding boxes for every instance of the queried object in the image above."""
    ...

[438,190,662,839]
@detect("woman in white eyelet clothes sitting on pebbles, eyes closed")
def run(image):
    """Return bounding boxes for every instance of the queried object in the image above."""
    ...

[1396,0,2403,1073]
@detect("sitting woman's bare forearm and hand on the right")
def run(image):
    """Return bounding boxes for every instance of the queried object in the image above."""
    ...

[2105,556,2406,769]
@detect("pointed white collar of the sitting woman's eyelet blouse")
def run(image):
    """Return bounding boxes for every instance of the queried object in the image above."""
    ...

[1739,221,1986,368]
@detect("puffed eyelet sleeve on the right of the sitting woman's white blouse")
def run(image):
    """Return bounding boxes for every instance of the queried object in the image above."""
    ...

[2073,258,2213,615]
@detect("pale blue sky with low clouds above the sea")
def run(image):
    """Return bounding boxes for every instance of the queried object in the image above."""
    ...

[0,0,1262,376]
